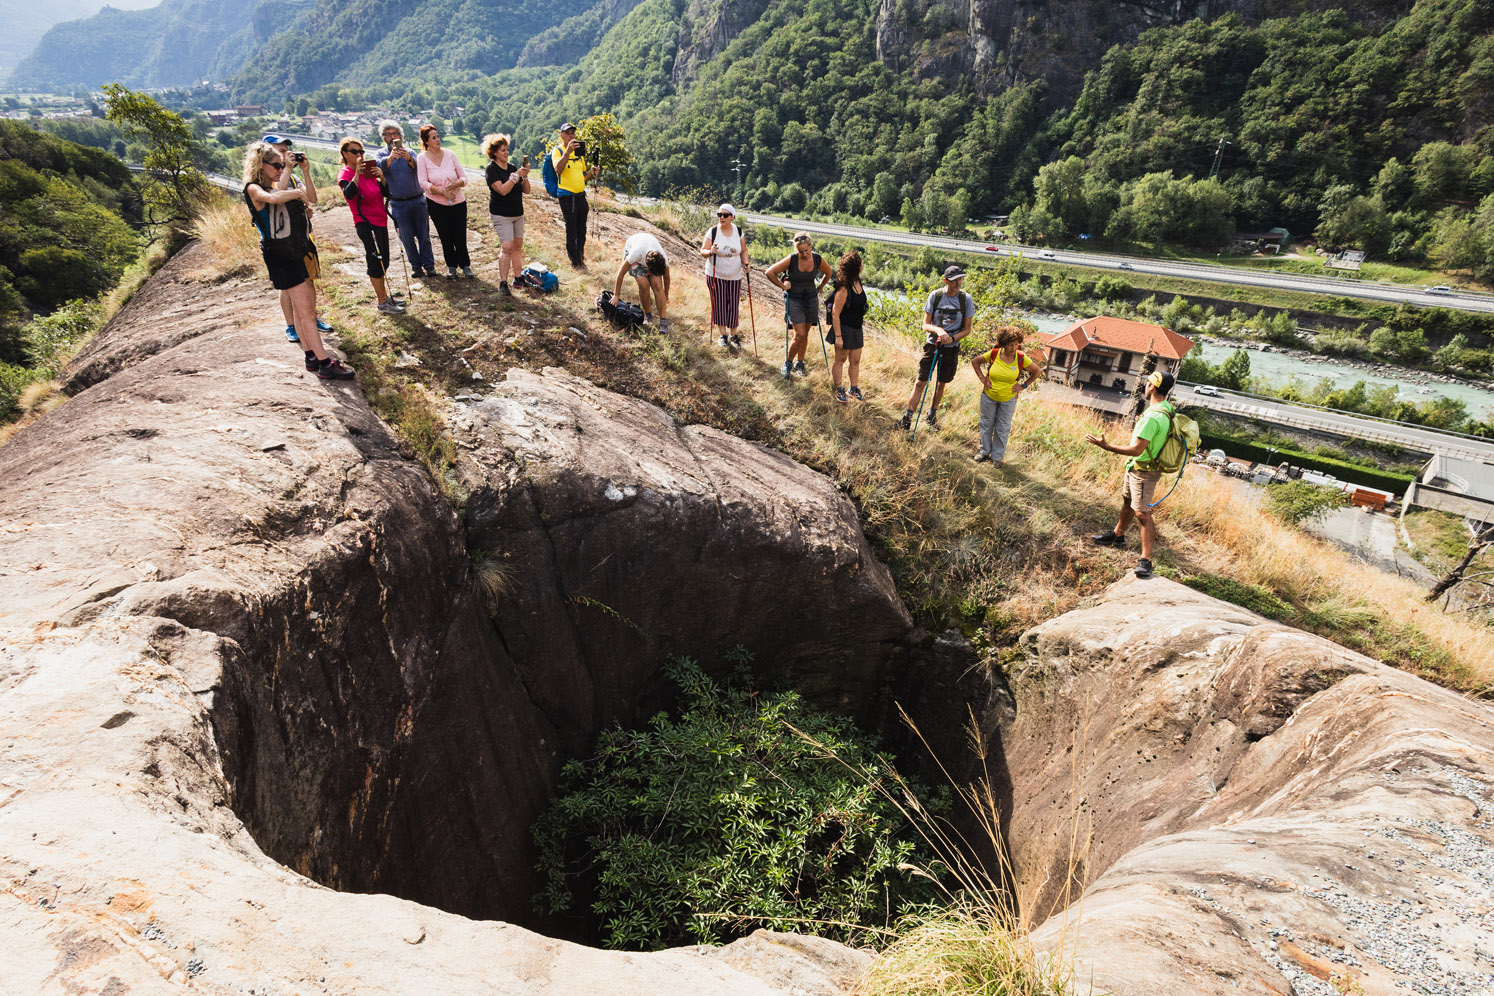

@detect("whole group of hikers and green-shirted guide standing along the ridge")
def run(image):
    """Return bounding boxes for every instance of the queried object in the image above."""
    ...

[244,121,1198,576]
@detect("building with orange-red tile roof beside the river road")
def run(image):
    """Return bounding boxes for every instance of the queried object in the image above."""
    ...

[1043,315,1194,394]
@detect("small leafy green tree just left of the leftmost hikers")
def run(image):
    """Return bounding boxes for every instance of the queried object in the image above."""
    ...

[103,84,209,230]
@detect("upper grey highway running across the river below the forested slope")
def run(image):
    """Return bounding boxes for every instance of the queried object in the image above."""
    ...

[743,212,1494,312]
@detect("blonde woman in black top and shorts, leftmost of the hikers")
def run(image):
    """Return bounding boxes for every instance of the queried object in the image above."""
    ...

[244,142,353,381]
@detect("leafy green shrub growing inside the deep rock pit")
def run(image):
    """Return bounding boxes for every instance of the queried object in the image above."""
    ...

[533,651,929,948]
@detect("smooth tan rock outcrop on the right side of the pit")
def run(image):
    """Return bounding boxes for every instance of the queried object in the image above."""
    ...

[1001,578,1494,996]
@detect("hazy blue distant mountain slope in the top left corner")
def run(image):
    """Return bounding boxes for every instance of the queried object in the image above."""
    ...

[10,0,255,87]
